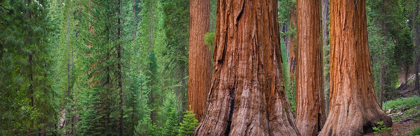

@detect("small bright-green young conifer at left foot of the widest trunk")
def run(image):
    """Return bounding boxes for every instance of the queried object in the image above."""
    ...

[178,110,198,136]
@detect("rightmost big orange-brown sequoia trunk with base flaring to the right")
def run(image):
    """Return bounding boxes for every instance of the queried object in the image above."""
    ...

[320,0,392,136]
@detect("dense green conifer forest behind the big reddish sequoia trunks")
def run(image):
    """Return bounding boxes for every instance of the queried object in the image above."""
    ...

[0,0,420,136]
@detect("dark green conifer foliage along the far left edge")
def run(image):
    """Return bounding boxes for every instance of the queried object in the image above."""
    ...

[0,0,58,135]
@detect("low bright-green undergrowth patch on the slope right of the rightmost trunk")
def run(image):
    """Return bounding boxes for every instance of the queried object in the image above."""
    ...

[382,96,420,110]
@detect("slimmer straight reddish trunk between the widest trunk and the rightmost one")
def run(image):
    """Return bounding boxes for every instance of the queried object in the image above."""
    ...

[296,0,325,136]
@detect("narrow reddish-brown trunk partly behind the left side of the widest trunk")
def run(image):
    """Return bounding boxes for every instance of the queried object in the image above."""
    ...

[188,0,212,121]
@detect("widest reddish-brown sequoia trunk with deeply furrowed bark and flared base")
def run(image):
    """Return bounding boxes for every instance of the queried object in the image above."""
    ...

[194,0,300,136]
